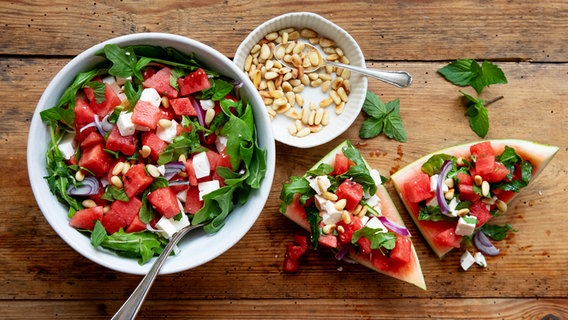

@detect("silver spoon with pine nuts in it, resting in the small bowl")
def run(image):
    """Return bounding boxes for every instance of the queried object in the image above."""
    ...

[274,42,412,88]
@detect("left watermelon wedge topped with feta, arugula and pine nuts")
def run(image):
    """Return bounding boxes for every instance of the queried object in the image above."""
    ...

[280,141,426,290]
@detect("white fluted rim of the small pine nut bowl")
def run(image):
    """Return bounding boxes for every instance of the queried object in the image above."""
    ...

[233,11,368,148]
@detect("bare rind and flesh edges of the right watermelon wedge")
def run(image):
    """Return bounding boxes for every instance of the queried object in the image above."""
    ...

[391,139,559,259]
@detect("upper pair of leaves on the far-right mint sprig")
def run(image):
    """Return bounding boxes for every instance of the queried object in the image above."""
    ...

[438,59,507,94]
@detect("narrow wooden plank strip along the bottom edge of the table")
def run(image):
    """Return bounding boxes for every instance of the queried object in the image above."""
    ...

[0,293,568,320]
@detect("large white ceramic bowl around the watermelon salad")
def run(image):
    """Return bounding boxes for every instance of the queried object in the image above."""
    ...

[27,33,276,274]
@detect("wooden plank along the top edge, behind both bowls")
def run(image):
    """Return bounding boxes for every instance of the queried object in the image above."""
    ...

[0,0,568,62]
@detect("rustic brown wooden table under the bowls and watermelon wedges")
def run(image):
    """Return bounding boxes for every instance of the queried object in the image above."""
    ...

[0,0,568,319]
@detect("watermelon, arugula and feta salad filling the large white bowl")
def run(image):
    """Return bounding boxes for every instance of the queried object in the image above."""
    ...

[41,44,266,264]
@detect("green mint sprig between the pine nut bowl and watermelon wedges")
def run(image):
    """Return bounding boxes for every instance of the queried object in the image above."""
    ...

[359,91,406,142]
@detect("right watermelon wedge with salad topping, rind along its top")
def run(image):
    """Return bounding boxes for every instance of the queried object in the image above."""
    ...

[391,139,558,258]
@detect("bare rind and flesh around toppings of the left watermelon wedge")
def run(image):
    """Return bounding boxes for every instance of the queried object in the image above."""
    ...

[284,141,426,290]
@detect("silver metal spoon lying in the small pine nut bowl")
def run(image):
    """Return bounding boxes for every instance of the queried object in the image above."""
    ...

[274,42,412,88]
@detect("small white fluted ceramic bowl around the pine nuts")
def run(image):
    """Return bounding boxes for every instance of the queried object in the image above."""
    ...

[233,12,367,148]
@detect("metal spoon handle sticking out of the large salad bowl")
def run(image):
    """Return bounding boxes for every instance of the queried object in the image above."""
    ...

[112,224,203,320]
